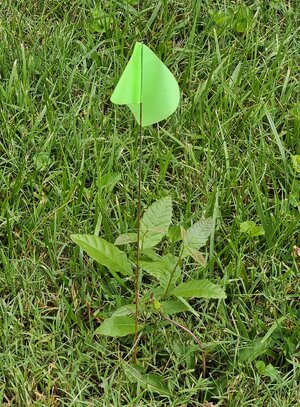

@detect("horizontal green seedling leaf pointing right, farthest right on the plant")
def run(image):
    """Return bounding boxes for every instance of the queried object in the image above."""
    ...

[171,280,226,299]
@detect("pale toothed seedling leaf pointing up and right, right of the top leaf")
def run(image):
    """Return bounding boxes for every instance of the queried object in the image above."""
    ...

[183,218,214,257]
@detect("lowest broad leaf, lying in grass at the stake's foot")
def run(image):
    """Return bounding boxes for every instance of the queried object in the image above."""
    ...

[124,365,171,396]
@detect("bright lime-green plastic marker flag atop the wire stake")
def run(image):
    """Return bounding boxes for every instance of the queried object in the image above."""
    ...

[111,42,180,126]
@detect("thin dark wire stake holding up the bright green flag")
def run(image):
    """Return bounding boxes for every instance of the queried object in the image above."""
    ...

[133,43,143,363]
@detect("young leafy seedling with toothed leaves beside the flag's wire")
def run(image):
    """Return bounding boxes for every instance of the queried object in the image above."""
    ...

[71,196,226,370]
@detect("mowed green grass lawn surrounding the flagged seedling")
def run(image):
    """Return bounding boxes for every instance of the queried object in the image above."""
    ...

[0,0,300,407]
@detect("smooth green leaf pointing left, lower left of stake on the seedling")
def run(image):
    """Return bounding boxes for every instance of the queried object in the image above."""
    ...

[95,315,142,337]
